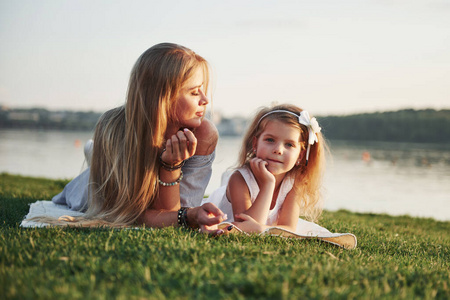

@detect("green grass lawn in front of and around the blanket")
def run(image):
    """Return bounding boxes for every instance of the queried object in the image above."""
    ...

[0,174,450,299]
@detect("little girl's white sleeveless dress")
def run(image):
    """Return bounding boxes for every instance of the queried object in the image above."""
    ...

[202,166,331,236]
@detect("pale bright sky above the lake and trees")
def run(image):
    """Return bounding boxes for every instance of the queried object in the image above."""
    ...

[0,0,450,116]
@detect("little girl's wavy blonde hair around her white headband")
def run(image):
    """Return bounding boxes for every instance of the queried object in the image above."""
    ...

[238,104,327,221]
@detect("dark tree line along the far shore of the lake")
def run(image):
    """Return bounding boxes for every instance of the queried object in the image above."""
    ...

[0,108,450,143]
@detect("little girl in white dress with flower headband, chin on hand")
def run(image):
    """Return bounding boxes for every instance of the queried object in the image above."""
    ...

[204,104,330,236]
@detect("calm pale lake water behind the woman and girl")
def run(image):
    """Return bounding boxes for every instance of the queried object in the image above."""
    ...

[0,130,450,221]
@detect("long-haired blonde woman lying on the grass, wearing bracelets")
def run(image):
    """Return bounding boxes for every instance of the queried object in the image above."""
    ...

[53,43,226,232]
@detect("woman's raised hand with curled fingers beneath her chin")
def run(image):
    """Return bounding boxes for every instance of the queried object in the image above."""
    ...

[161,128,197,166]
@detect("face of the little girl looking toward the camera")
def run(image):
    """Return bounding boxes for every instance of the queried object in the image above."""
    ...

[253,120,301,175]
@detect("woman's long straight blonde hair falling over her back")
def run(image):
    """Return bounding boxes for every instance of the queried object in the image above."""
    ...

[81,43,209,225]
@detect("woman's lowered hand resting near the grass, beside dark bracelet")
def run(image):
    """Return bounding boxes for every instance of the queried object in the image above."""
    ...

[188,203,227,235]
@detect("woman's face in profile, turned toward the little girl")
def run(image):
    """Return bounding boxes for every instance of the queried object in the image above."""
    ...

[176,68,209,128]
